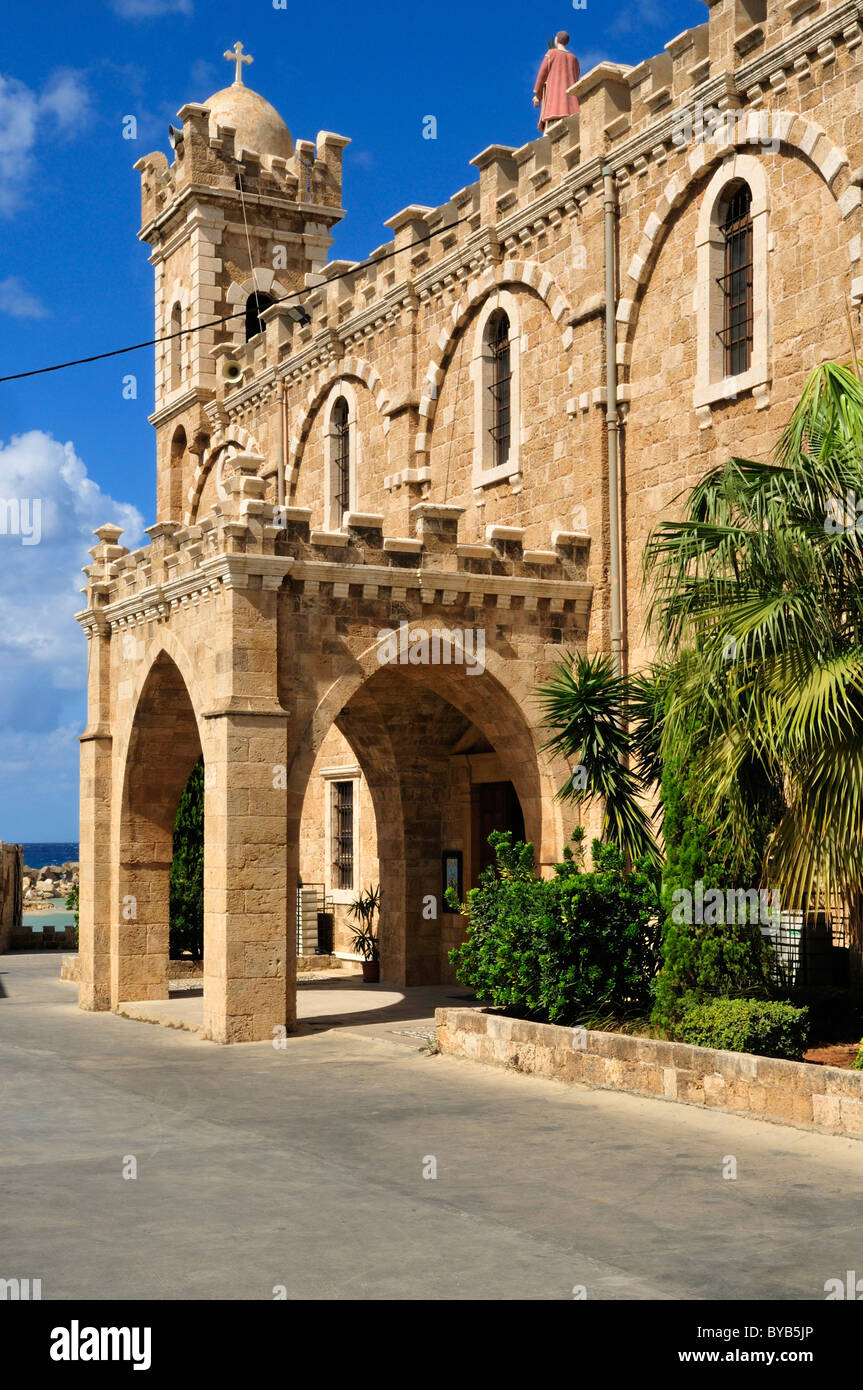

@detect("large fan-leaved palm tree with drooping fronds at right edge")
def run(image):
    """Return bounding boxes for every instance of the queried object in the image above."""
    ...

[645,363,863,939]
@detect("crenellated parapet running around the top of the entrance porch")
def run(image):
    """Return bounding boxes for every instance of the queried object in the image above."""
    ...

[78,472,592,635]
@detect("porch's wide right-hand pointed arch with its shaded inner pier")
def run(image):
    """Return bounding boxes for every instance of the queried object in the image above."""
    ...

[288,653,547,986]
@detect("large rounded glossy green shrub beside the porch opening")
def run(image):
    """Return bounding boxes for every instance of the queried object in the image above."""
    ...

[450,831,657,1024]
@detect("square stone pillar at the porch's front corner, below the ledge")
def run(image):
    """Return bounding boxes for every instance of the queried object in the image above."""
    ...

[204,713,297,1043]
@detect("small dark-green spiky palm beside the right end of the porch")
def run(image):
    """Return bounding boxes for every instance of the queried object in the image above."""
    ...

[536,655,664,865]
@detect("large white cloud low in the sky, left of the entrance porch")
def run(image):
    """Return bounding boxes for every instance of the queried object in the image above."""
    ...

[0,430,143,741]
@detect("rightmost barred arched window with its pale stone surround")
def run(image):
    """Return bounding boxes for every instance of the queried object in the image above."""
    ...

[693,154,770,411]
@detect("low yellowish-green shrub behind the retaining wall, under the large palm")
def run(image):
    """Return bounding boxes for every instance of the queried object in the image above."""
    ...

[674,999,809,1061]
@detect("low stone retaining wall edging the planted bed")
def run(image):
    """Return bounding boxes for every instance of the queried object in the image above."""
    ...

[435,1009,863,1138]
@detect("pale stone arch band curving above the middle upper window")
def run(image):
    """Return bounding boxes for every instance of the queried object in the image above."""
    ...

[417,261,573,466]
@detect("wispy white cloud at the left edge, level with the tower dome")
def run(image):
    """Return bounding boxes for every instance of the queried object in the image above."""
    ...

[0,68,90,215]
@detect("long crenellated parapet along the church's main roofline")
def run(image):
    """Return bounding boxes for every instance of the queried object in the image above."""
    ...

[198,0,863,409]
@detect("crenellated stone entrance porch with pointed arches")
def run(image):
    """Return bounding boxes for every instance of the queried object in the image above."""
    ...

[79,492,592,1043]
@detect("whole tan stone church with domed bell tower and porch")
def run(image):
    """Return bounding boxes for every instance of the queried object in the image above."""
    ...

[79,0,863,1043]
